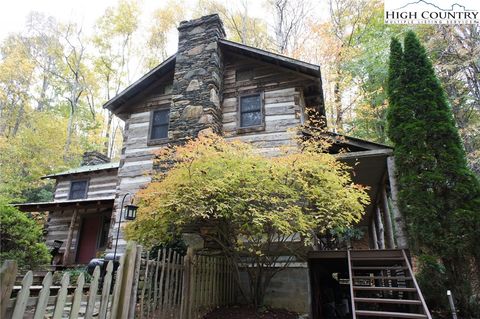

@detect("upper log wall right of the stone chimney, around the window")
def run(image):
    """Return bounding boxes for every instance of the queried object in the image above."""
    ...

[222,57,310,156]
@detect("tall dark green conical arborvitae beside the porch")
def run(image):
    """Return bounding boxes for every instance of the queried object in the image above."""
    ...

[388,32,480,317]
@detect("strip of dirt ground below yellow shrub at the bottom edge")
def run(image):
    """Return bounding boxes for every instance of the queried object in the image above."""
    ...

[204,306,298,319]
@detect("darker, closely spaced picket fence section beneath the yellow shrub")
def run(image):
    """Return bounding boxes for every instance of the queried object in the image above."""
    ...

[136,249,236,319]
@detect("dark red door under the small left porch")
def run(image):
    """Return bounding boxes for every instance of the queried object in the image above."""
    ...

[77,216,101,264]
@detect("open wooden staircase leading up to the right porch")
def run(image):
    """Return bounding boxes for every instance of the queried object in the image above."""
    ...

[347,249,432,319]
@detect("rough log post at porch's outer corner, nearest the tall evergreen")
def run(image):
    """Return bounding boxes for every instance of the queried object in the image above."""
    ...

[387,156,408,249]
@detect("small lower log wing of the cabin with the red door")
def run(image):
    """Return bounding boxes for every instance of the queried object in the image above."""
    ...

[16,151,118,265]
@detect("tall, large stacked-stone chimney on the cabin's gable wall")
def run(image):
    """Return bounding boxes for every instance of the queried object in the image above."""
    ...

[169,14,225,142]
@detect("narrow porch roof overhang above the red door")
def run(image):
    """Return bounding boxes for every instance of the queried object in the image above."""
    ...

[12,197,115,212]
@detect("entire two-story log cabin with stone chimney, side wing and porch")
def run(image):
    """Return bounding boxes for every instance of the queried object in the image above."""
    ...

[18,15,430,318]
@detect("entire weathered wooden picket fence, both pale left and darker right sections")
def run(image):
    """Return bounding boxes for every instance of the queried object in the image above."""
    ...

[0,243,237,319]
